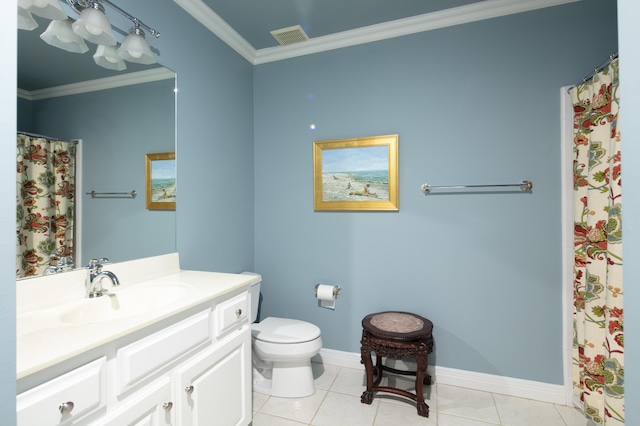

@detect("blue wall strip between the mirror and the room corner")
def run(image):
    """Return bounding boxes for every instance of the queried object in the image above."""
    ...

[138,0,254,272]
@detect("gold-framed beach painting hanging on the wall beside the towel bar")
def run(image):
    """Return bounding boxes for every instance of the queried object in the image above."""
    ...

[313,135,398,211]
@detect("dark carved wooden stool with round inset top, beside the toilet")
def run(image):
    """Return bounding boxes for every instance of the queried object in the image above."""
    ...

[360,312,433,417]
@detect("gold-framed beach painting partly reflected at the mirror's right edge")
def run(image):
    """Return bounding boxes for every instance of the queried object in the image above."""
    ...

[144,152,176,210]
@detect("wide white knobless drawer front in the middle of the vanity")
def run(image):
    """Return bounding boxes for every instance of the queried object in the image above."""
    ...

[116,308,211,395]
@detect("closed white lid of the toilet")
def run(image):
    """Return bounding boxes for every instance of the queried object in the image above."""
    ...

[251,317,320,343]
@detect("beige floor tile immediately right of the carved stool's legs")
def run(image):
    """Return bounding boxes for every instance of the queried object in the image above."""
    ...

[437,384,500,424]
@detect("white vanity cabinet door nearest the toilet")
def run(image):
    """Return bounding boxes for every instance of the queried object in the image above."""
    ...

[174,325,251,426]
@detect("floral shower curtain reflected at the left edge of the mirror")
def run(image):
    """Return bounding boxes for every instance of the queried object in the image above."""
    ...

[16,134,76,278]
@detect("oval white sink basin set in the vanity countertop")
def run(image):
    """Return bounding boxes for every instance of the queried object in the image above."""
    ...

[60,283,191,324]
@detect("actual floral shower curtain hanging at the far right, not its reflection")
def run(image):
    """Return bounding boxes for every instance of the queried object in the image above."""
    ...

[570,58,624,425]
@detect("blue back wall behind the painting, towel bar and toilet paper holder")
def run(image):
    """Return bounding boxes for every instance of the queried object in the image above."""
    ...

[254,0,617,384]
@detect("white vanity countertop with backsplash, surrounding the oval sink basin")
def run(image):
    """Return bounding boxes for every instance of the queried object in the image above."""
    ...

[16,253,258,379]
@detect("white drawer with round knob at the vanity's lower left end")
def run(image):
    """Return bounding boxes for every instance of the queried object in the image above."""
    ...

[16,358,106,426]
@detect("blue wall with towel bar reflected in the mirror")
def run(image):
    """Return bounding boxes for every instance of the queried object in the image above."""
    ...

[33,80,176,266]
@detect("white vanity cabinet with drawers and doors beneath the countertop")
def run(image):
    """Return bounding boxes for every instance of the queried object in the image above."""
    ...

[17,287,252,426]
